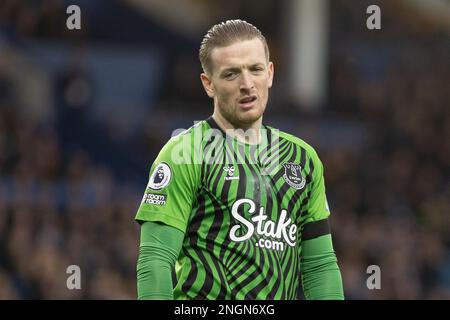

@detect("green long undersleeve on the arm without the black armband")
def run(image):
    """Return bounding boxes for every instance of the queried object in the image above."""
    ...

[137,222,184,299]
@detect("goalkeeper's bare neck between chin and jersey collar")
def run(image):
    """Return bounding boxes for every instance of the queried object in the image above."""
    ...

[213,111,262,144]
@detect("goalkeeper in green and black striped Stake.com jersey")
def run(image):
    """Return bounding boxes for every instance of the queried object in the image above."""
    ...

[135,20,344,299]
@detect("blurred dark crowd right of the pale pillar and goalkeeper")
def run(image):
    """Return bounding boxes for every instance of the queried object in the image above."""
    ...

[322,1,450,299]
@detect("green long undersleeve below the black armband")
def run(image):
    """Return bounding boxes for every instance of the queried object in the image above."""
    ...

[301,234,344,300]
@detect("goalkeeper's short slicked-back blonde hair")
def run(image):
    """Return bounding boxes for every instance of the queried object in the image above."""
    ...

[199,19,270,74]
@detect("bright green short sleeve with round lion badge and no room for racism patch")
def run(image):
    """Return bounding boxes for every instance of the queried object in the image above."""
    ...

[135,134,199,232]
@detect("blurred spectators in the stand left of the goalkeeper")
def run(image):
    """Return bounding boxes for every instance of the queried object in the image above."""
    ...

[0,105,140,299]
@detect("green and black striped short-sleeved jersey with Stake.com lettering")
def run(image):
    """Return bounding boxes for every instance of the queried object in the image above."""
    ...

[136,117,330,299]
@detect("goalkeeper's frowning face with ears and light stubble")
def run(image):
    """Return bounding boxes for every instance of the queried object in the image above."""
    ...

[201,38,273,128]
